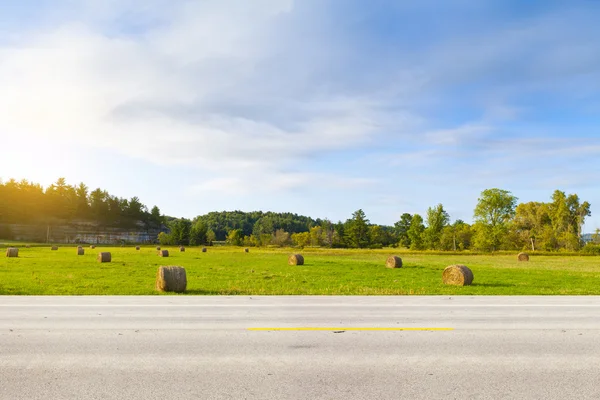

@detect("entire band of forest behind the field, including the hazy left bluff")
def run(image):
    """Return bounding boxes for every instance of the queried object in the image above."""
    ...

[0,178,600,253]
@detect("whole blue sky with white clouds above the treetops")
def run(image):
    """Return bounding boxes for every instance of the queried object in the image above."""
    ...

[0,0,600,232]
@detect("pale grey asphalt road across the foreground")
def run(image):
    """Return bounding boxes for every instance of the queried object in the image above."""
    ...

[0,296,600,400]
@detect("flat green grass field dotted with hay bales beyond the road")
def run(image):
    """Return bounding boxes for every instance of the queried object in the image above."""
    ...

[0,245,600,295]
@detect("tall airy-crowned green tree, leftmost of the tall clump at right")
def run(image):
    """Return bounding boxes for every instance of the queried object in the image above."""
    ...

[473,188,517,251]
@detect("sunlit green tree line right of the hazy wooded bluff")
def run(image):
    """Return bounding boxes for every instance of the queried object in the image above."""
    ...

[160,188,600,251]
